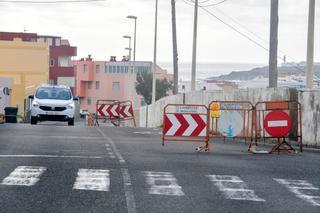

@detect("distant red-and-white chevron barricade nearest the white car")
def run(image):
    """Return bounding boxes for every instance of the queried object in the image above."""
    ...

[95,100,120,126]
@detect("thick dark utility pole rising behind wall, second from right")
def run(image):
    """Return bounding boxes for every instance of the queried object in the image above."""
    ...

[269,0,279,88]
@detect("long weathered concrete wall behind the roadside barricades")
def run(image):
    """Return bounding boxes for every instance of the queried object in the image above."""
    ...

[135,88,320,147]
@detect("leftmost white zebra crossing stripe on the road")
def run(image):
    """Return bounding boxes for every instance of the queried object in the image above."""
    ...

[1,166,46,186]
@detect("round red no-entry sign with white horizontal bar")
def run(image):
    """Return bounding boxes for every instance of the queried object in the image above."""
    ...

[263,110,292,138]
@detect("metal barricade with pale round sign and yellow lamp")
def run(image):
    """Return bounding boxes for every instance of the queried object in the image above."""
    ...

[209,101,253,145]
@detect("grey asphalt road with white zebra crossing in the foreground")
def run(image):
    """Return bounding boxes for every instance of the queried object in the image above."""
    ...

[0,123,320,213]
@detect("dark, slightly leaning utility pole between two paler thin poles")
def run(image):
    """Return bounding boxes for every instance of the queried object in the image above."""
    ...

[171,0,179,95]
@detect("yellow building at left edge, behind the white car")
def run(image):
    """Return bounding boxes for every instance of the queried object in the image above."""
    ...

[0,39,49,113]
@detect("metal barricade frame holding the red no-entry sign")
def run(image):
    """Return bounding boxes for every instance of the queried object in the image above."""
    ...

[249,101,303,153]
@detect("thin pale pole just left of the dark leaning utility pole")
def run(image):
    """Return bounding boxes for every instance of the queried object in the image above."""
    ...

[151,0,158,104]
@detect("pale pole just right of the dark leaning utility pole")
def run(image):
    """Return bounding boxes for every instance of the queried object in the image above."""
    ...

[191,0,198,91]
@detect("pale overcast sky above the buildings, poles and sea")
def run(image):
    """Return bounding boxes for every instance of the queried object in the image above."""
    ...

[0,0,320,64]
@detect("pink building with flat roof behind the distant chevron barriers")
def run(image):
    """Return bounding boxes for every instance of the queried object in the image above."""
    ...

[74,55,173,113]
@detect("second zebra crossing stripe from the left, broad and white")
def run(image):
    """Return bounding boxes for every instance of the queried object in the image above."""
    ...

[73,169,110,191]
